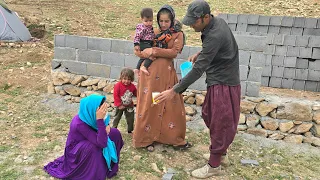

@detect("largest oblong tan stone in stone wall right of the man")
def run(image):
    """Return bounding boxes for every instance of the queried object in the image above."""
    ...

[277,103,312,121]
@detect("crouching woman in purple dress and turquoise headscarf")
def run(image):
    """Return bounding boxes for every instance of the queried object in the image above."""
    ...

[44,95,123,180]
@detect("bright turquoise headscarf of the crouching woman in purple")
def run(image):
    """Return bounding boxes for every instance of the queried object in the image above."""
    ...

[79,94,118,171]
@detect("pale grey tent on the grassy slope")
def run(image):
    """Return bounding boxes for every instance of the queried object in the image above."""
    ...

[0,0,31,41]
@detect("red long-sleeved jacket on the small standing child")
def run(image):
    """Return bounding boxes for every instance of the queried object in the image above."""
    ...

[113,81,137,107]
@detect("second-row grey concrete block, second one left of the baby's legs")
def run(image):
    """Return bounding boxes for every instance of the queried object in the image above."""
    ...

[101,52,125,67]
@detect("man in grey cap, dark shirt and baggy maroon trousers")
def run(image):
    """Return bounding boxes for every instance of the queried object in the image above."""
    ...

[156,0,241,178]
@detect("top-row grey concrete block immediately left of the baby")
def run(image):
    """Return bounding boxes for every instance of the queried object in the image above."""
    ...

[111,39,134,54]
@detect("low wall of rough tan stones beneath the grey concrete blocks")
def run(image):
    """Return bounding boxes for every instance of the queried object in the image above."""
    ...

[48,68,320,146]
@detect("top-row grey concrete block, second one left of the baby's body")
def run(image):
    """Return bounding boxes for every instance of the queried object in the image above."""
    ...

[88,37,112,52]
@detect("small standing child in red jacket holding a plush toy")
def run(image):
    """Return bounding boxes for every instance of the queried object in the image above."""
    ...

[113,68,137,134]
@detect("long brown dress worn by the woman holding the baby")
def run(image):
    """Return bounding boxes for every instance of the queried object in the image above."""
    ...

[133,32,186,147]
